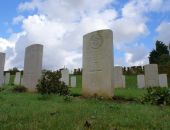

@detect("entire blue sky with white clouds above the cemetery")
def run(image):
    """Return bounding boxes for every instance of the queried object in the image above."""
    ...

[0,0,170,70]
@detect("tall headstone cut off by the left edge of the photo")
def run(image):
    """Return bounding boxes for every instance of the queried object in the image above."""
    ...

[0,52,5,86]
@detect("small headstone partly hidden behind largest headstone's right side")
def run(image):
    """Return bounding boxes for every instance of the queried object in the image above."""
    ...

[113,66,124,88]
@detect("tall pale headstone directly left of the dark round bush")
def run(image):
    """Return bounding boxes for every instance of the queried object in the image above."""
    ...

[23,44,43,91]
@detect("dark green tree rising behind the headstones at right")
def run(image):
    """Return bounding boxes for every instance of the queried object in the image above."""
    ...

[149,41,170,65]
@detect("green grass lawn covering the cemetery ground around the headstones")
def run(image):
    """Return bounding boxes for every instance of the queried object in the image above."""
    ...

[0,76,170,130]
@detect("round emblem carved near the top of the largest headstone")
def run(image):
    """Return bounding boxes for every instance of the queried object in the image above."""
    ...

[90,34,103,49]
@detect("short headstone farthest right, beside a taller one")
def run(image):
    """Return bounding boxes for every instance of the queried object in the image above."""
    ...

[159,74,168,87]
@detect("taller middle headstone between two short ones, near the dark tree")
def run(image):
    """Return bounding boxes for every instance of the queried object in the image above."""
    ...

[144,64,159,87]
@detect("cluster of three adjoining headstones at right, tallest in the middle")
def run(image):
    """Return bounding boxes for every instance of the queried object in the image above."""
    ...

[137,64,168,88]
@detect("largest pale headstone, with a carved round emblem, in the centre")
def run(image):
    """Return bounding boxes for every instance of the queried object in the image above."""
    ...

[82,30,113,98]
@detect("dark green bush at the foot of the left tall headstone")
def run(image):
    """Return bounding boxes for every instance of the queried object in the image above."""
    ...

[36,71,69,95]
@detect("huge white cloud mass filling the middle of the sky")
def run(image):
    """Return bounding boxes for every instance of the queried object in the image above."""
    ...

[1,0,170,69]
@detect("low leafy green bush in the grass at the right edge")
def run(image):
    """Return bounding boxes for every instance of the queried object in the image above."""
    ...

[142,87,170,105]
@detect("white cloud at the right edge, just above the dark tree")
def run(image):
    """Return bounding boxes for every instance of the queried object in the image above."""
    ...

[156,22,170,44]
